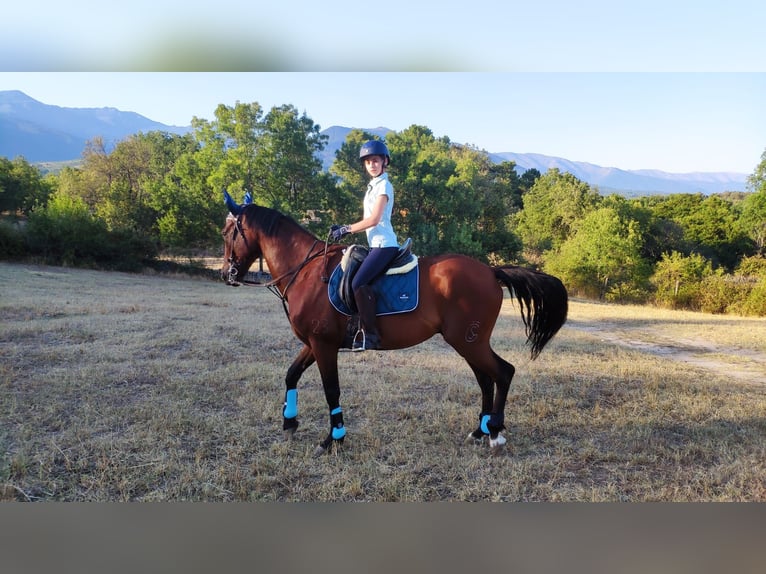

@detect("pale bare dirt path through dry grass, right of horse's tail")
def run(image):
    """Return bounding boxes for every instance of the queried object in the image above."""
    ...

[566,320,766,384]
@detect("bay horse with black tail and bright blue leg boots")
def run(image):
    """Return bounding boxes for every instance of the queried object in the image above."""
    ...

[221,193,568,456]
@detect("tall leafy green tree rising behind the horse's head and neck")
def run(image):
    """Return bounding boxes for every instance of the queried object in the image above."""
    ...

[184,102,333,238]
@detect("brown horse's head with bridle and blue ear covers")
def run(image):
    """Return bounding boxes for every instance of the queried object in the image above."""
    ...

[221,191,260,287]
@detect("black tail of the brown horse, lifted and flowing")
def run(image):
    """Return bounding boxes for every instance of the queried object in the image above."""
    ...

[493,265,569,359]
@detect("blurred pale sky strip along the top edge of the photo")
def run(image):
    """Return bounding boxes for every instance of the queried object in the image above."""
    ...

[0,0,766,72]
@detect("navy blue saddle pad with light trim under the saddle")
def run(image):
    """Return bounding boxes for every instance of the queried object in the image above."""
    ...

[327,265,420,315]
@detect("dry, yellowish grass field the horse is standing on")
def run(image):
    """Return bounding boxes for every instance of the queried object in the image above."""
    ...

[0,263,766,501]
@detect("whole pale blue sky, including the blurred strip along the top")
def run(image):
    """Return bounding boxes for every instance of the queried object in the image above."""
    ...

[0,0,766,174]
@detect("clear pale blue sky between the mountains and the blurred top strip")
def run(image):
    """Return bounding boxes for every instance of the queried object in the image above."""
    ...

[0,72,766,174]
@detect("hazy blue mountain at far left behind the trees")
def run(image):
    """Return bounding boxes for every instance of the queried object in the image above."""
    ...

[0,90,191,163]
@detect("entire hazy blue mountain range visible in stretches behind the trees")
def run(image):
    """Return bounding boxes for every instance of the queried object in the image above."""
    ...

[0,90,747,195]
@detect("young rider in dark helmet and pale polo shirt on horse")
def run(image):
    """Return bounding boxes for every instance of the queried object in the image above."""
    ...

[330,140,399,351]
